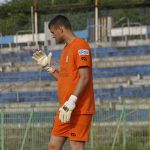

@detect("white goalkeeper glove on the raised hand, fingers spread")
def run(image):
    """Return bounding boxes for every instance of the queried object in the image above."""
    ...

[32,50,55,73]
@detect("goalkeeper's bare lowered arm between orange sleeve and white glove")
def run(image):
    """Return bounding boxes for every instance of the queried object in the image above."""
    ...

[72,67,90,97]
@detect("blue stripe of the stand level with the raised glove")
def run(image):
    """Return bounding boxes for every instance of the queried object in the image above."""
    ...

[0,46,150,62]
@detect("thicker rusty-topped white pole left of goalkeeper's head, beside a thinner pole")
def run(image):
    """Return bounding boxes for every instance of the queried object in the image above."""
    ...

[34,0,38,48]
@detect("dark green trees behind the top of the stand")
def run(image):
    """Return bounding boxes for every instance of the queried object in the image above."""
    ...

[0,0,150,35]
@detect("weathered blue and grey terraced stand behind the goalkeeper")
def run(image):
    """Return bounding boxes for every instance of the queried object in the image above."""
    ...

[0,46,150,149]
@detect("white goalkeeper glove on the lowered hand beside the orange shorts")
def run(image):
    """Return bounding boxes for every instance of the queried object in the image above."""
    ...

[59,95,77,123]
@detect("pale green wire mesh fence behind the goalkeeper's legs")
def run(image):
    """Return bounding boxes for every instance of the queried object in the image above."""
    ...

[0,99,150,150]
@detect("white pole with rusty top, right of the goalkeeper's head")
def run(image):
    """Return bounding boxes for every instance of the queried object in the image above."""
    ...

[95,0,100,42]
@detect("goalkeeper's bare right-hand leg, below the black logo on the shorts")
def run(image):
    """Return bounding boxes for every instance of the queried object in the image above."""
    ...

[70,141,85,150]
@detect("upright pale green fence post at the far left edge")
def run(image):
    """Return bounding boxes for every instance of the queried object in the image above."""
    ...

[1,107,4,150]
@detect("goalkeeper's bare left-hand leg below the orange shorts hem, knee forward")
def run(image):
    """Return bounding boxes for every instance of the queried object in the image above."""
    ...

[48,136,66,150]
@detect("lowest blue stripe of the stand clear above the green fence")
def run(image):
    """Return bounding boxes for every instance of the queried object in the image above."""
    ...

[0,86,150,102]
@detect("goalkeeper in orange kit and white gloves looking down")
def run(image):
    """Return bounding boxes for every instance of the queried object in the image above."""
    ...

[33,15,95,150]
